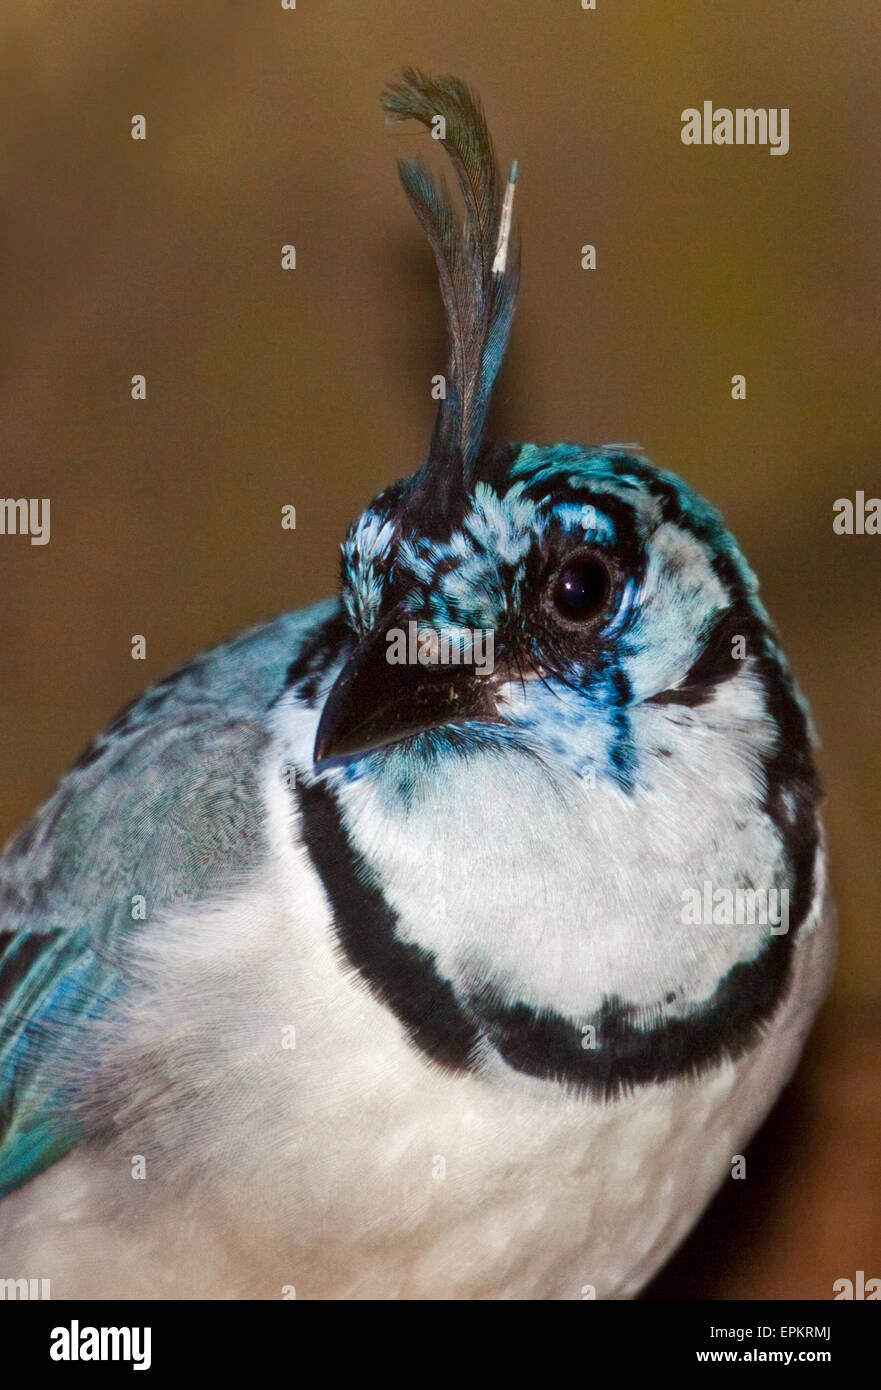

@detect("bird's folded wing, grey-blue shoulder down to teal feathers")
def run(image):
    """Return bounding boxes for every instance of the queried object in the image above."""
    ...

[0,605,335,1195]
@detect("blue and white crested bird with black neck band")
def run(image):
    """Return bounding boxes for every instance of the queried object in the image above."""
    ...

[0,68,835,1300]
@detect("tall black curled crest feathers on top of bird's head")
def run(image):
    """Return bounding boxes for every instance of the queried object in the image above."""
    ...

[382,68,520,528]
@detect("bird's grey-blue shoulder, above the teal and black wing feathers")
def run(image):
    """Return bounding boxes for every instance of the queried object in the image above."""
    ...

[0,603,336,937]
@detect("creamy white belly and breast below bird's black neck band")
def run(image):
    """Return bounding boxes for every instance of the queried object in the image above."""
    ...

[0,870,832,1300]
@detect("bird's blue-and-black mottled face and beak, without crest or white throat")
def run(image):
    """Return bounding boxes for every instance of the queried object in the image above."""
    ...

[315,445,784,790]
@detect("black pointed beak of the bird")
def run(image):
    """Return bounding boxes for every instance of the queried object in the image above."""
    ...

[313,614,500,763]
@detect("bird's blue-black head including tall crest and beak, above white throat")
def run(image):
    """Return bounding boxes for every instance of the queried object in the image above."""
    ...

[314,71,798,806]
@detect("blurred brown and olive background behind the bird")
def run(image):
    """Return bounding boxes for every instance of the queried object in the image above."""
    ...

[0,0,881,1298]
